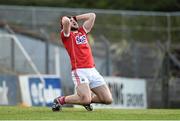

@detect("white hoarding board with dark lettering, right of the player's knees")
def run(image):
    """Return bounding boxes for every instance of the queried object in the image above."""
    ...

[94,77,147,109]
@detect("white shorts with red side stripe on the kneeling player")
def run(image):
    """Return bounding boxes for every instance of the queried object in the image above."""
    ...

[71,68,106,89]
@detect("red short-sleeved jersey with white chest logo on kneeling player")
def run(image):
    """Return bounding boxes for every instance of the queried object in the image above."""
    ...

[61,27,95,70]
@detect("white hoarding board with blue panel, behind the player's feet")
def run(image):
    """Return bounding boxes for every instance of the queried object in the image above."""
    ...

[19,75,62,106]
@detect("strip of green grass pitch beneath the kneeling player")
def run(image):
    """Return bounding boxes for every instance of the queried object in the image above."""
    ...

[0,106,180,120]
